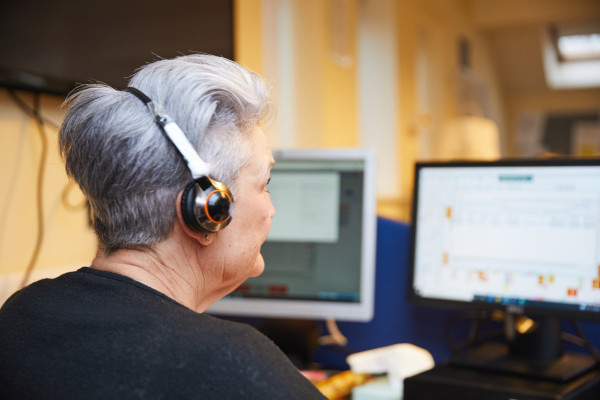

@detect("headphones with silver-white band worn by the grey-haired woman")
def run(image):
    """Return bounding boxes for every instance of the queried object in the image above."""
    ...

[123,87,234,233]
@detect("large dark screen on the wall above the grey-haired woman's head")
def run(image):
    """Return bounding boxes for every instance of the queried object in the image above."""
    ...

[0,0,234,94]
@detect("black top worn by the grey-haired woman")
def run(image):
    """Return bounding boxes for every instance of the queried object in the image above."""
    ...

[0,268,325,400]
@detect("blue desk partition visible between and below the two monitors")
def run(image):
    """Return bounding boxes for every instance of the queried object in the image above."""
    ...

[314,218,600,369]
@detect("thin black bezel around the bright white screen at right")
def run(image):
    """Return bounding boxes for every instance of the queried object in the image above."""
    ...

[406,157,600,321]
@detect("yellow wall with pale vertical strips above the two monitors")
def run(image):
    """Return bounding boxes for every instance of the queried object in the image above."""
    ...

[237,0,504,220]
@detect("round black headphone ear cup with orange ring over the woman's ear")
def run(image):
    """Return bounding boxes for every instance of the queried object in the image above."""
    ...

[181,176,234,233]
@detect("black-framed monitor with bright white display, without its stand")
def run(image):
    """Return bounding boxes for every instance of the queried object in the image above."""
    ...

[409,159,600,319]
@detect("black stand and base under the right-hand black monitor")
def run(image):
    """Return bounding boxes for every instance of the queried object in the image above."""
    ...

[449,314,597,382]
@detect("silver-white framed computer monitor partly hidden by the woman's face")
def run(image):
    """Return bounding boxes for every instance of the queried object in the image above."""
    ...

[209,149,376,321]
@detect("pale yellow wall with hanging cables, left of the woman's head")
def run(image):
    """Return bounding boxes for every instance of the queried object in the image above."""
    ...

[0,89,96,273]
